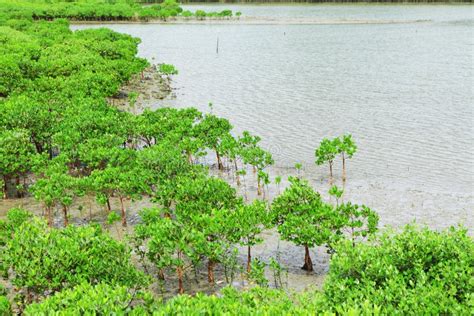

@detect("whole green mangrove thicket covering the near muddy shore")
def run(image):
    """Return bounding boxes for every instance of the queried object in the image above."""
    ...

[0,1,474,315]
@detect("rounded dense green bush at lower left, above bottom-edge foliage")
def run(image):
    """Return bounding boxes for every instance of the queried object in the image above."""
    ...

[2,219,147,295]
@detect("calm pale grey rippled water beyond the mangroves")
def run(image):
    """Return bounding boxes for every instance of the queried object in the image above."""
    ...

[74,5,474,227]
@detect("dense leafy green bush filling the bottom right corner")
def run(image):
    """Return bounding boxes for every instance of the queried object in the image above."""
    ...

[324,226,474,315]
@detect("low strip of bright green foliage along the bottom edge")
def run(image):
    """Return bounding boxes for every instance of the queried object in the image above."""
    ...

[25,284,386,316]
